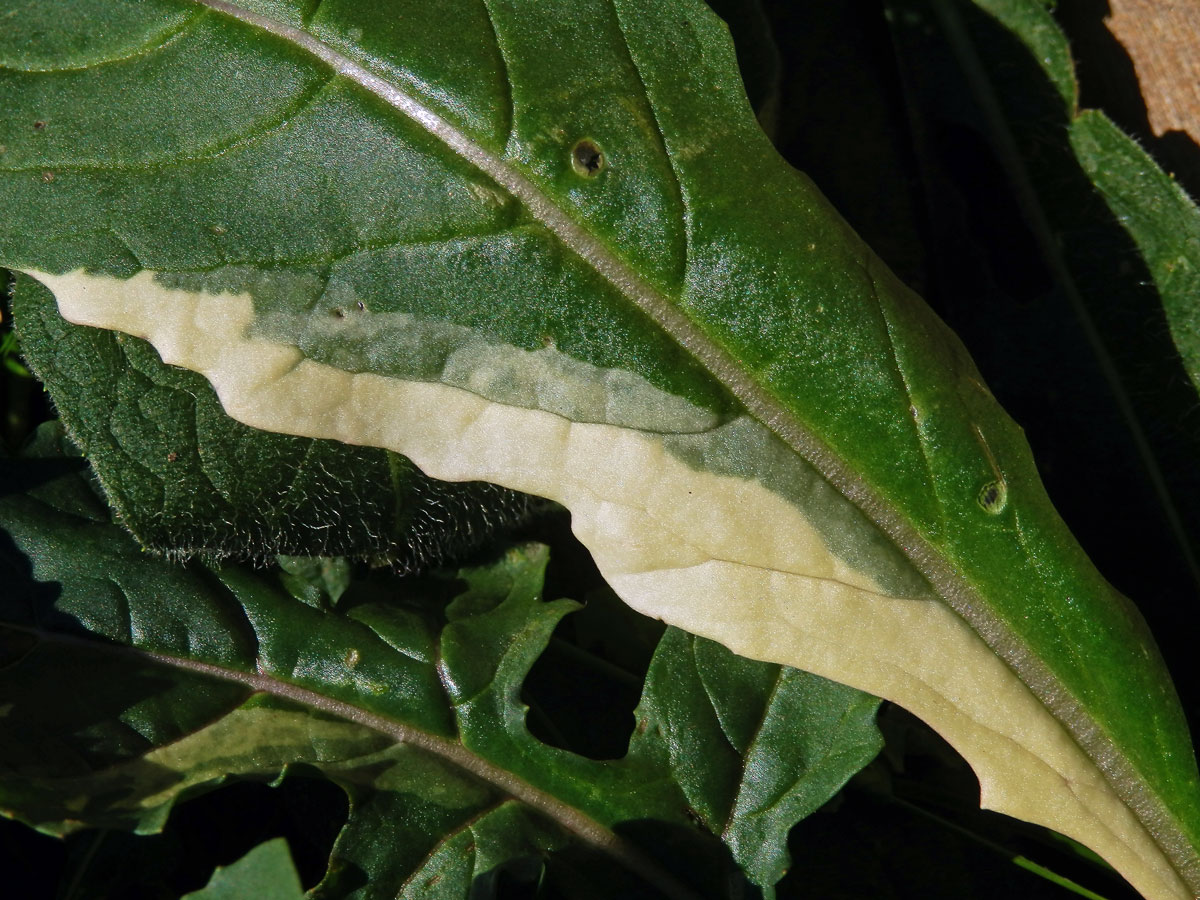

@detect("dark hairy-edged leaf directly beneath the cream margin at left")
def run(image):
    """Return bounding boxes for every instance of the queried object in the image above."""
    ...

[16,276,529,569]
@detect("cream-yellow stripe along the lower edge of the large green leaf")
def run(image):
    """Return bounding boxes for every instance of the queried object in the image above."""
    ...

[32,272,1190,899]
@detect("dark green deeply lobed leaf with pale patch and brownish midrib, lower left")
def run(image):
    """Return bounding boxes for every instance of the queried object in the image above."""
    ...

[0,448,878,896]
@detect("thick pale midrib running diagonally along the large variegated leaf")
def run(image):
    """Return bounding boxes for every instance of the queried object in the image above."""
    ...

[184,0,1187,888]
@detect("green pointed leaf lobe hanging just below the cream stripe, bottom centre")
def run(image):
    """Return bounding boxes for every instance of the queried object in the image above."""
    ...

[638,629,882,886]
